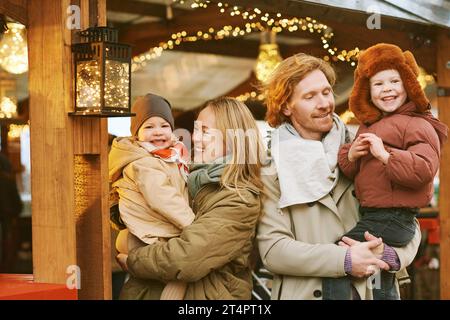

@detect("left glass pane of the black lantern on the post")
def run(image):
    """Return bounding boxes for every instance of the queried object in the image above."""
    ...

[77,60,101,109]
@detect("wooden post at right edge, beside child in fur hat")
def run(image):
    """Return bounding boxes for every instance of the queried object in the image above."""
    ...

[437,30,450,300]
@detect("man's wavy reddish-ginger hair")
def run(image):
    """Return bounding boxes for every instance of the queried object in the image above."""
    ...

[260,53,336,128]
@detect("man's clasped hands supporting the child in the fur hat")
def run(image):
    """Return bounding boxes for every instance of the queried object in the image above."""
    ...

[342,237,389,278]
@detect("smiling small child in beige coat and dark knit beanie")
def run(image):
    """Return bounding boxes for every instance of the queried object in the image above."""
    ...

[109,94,194,300]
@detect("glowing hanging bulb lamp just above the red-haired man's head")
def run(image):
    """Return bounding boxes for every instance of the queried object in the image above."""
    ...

[254,31,283,81]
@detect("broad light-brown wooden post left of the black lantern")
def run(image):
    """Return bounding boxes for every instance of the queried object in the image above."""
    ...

[28,0,77,284]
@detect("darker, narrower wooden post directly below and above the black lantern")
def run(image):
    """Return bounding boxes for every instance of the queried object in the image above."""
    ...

[73,0,112,299]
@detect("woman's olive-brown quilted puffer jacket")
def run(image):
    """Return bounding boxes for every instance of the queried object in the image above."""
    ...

[121,183,261,300]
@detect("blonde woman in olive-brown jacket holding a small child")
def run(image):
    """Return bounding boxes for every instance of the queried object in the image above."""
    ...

[121,98,264,300]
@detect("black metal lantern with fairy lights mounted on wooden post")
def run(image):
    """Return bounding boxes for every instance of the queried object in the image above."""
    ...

[70,27,134,117]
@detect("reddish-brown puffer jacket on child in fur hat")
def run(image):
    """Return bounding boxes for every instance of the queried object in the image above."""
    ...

[339,102,447,208]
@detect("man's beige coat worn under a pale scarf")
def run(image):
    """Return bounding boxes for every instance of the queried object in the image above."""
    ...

[257,162,421,300]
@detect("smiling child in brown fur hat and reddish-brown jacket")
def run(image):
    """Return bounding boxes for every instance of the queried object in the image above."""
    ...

[323,43,448,300]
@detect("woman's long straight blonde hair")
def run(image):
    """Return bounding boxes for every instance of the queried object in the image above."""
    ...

[204,97,265,193]
